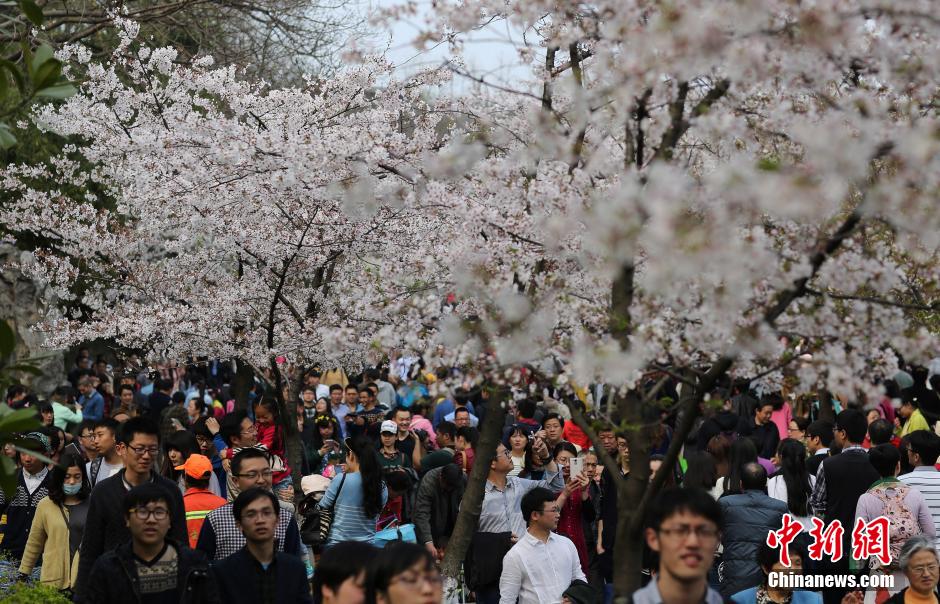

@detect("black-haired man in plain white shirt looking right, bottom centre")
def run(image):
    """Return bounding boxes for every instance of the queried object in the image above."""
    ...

[499,487,587,604]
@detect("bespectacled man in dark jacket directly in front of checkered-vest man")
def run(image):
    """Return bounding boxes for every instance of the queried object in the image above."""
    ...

[212,487,312,604]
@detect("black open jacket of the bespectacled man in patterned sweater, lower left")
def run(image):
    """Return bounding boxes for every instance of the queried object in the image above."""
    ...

[75,539,221,604]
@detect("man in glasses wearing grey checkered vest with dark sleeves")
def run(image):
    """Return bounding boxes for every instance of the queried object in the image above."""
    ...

[196,448,307,560]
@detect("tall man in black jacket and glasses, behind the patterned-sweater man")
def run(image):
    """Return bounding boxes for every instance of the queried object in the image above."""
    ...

[75,417,186,595]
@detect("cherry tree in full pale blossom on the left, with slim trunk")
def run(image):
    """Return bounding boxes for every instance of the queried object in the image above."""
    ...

[2,22,441,488]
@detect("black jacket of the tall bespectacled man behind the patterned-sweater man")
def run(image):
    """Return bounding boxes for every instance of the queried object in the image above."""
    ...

[75,470,189,594]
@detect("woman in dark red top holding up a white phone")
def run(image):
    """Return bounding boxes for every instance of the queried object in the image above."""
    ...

[553,441,596,575]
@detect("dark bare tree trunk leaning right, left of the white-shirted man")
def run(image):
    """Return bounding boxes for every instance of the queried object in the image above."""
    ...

[441,390,506,579]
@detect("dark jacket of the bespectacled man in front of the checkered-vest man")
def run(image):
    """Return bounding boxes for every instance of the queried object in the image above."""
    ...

[212,547,313,604]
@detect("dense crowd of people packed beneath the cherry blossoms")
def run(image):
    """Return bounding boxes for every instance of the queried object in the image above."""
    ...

[0,349,940,604]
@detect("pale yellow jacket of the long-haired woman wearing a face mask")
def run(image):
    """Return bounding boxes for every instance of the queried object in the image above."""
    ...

[20,497,78,589]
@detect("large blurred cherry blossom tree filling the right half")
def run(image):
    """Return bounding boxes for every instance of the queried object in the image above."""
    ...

[374,0,940,595]
